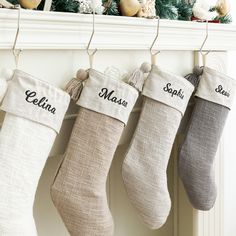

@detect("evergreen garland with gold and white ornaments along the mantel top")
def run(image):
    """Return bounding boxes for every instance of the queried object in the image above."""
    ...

[4,0,232,24]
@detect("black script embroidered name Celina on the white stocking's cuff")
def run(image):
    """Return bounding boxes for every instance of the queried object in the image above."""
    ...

[25,90,56,114]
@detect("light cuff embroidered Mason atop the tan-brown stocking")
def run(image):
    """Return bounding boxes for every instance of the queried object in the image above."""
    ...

[77,69,138,124]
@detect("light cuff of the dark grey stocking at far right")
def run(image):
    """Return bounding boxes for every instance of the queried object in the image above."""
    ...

[195,67,236,109]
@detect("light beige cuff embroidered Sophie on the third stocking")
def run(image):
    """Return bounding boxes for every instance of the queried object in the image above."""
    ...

[142,65,194,115]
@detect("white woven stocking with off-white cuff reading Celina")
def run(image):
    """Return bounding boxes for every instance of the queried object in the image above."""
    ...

[0,70,70,236]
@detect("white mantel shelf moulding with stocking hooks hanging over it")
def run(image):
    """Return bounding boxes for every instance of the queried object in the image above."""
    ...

[0,9,236,51]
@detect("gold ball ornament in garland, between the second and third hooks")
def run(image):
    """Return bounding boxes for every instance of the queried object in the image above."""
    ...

[120,0,141,16]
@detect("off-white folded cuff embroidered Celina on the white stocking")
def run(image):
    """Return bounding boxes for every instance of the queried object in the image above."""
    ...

[1,70,70,132]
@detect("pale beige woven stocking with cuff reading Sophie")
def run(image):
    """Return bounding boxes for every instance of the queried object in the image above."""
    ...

[122,66,193,229]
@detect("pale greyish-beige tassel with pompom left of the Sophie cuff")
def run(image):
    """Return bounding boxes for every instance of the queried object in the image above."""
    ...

[128,62,151,91]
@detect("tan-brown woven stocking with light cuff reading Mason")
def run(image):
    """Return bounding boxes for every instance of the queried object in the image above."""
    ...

[51,69,138,236]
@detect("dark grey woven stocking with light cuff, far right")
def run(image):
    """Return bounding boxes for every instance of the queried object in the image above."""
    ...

[179,68,236,210]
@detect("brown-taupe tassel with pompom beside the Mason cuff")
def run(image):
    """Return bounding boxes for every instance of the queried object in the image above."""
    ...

[66,69,89,102]
